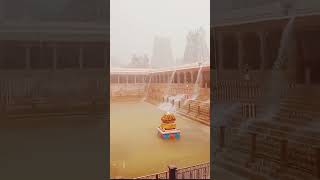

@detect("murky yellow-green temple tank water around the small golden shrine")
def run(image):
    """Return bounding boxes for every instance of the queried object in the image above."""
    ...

[110,102,210,178]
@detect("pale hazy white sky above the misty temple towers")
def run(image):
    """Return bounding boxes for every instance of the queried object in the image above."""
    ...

[110,0,210,63]
